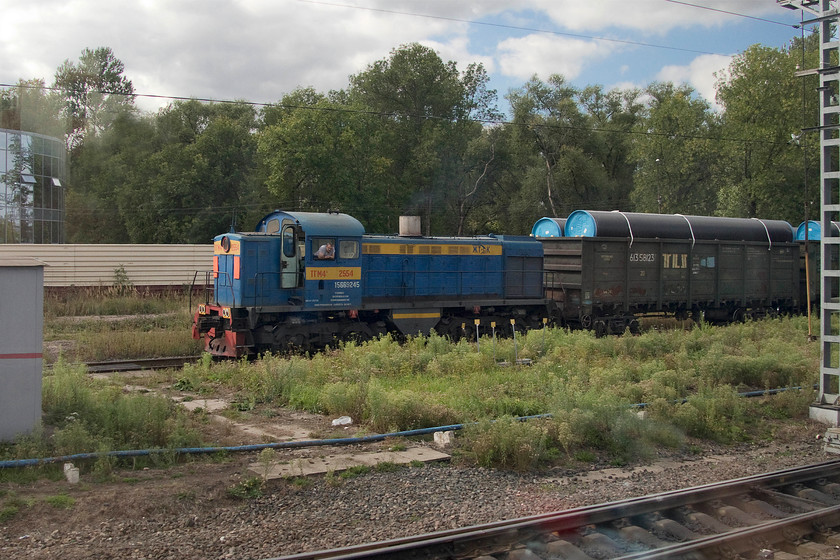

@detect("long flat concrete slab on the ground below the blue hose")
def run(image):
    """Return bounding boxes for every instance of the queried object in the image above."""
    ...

[248,447,450,480]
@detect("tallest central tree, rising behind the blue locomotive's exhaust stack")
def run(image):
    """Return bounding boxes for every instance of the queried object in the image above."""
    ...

[349,43,498,234]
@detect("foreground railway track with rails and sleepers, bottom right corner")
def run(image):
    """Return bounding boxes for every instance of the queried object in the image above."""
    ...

[281,461,840,560]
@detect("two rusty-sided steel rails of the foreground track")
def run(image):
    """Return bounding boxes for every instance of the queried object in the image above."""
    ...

[274,461,840,560]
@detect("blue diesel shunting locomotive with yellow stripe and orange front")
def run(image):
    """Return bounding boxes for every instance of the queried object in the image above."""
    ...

[193,211,550,357]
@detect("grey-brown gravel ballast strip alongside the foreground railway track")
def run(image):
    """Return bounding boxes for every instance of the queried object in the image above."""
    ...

[0,421,838,560]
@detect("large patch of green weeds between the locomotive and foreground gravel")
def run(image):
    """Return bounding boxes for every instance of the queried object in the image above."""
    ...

[173,317,818,470]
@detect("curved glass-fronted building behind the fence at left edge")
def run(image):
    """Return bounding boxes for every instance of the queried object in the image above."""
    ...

[0,129,67,243]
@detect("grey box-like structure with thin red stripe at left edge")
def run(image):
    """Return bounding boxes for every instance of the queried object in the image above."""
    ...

[0,258,44,441]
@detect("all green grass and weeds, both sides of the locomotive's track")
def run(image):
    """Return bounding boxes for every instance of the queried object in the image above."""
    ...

[27,294,819,471]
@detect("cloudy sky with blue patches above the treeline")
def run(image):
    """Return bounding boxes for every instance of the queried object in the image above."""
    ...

[0,0,809,116]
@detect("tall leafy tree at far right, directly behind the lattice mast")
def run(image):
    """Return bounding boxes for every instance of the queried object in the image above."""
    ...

[717,34,816,223]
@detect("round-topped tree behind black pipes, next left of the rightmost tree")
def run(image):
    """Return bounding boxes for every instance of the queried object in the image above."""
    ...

[631,83,721,215]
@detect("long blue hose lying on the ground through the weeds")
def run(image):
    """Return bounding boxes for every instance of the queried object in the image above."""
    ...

[0,385,817,469]
